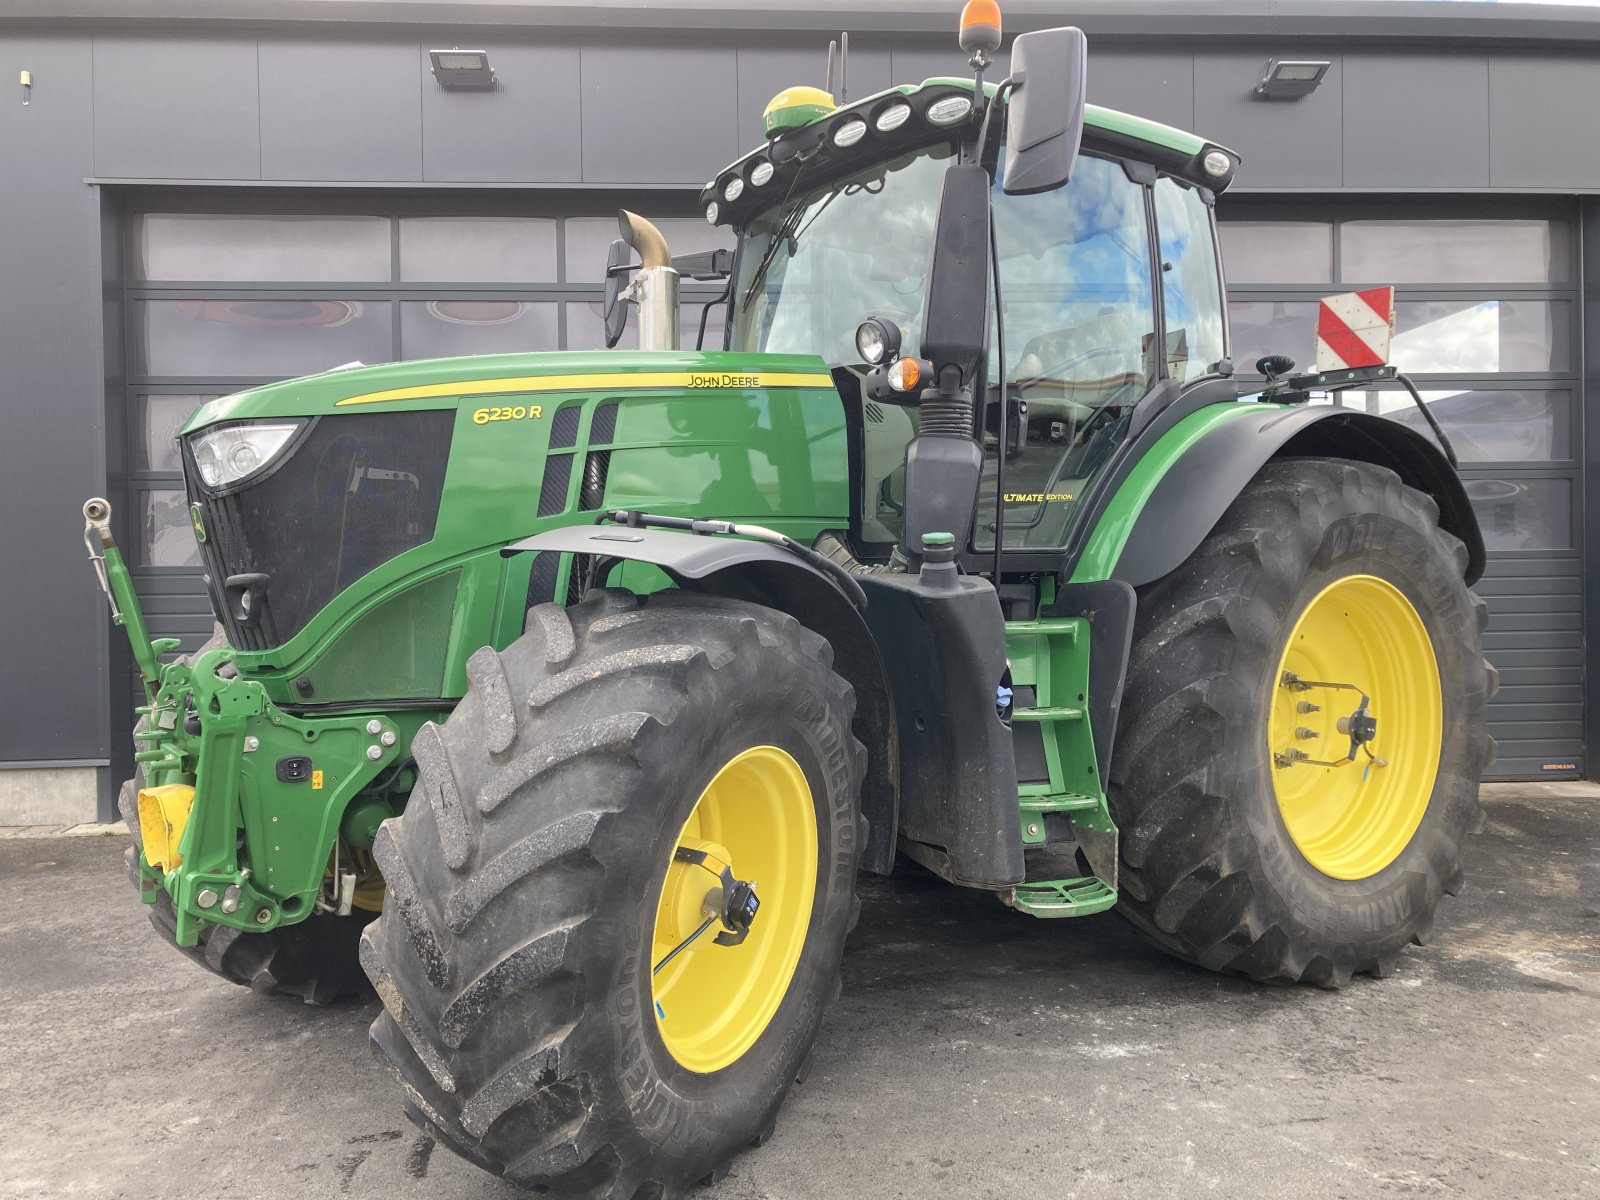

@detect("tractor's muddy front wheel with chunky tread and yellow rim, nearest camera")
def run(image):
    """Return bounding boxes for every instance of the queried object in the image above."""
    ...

[362,592,864,1197]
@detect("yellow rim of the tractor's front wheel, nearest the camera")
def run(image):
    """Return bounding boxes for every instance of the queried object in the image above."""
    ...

[650,746,818,1074]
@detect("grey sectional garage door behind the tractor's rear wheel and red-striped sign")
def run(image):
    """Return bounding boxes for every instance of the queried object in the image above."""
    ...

[1219,197,1584,779]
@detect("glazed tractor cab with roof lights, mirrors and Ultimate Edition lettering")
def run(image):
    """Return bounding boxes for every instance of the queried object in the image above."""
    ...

[611,29,1237,584]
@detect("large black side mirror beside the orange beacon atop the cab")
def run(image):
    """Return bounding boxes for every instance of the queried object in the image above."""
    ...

[1002,26,1090,195]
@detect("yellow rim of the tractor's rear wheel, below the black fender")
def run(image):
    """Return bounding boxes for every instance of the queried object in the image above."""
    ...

[1267,574,1445,880]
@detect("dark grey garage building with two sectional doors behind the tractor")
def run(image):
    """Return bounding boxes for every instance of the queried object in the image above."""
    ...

[0,0,1600,824]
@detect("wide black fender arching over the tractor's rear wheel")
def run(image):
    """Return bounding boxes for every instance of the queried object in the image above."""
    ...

[1112,405,1483,587]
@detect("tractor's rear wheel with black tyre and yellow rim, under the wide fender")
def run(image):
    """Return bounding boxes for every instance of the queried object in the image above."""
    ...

[1109,459,1496,987]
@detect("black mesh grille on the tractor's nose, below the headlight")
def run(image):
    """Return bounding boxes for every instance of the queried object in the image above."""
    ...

[193,410,454,650]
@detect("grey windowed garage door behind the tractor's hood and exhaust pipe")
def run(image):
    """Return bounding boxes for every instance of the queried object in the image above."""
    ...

[112,194,728,744]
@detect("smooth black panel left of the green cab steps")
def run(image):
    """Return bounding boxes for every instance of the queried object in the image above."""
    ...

[861,574,1024,888]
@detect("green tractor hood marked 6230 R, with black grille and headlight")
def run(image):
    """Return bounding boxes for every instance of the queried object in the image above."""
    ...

[179,350,850,681]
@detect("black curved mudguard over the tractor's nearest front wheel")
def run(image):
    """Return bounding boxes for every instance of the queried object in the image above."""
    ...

[501,525,902,875]
